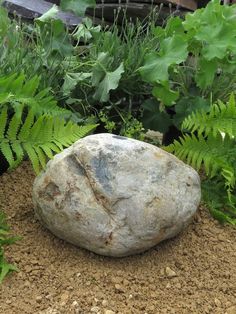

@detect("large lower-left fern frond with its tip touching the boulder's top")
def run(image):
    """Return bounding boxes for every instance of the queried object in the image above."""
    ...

[0,108,96,173]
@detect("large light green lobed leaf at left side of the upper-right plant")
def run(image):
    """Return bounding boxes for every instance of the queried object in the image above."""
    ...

[139,35,188,83]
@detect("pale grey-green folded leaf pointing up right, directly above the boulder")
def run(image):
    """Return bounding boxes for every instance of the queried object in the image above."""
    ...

[94,63,125,102]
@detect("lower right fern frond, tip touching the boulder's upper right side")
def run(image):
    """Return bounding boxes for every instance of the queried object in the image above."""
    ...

[166,134,236,211]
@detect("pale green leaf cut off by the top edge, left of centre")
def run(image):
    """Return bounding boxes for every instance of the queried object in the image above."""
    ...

[60,0,96,16]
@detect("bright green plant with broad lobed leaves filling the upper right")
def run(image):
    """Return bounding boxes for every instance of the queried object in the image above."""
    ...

[139,0,236,132]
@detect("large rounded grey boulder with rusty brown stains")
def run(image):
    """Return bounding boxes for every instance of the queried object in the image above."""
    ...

[33,134,201,256]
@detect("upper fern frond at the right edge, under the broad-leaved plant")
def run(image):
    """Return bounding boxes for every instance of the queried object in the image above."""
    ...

[182,94,236,138]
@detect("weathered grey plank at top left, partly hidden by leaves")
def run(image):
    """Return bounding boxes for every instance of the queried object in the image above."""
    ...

[3,0,82,26]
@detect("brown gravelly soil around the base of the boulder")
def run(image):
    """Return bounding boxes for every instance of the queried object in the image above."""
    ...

[0,163,236,314]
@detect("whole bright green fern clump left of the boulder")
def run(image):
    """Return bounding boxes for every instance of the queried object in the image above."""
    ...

[0,74,96,173]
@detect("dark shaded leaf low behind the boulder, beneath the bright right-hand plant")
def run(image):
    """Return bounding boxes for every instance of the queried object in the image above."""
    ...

[142,99,172,133]
